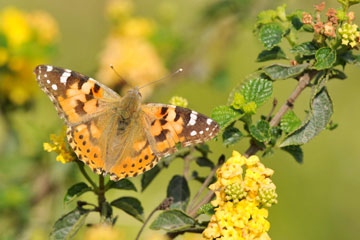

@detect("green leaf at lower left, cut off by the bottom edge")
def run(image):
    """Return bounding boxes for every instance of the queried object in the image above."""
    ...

[50,208,90,240]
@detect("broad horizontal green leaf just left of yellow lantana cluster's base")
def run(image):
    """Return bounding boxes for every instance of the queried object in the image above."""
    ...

[150,209,195,232]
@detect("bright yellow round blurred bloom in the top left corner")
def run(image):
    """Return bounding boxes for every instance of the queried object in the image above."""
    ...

[0,7,31,47]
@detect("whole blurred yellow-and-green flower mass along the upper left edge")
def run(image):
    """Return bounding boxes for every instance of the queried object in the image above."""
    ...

[0,7,58,105]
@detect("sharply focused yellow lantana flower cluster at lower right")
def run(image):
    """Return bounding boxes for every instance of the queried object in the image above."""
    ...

[203,151,277,240]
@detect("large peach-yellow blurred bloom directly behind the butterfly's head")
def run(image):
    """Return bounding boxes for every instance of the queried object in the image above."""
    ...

[97,35,166,97]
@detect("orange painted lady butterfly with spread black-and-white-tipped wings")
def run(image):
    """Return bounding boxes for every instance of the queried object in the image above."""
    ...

[34,65,219,181]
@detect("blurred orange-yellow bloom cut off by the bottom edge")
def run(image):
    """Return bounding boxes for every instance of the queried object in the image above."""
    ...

[84,225,126,240]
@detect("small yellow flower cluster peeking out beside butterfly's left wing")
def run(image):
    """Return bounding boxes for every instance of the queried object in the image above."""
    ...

[43,127,76,164]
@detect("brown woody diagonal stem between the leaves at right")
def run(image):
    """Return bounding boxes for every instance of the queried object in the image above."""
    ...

[245,71,317,157]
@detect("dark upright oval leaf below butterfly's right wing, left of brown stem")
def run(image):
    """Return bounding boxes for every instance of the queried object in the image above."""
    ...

[166,175,190,210]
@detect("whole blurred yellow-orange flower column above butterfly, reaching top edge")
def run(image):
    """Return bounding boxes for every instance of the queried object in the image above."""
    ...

[97,0,167,97]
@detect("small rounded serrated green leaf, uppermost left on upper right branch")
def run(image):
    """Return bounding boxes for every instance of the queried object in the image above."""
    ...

[259,23,283,49]
